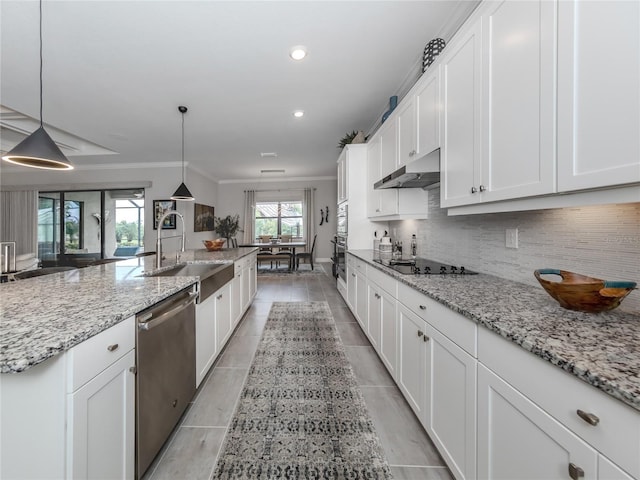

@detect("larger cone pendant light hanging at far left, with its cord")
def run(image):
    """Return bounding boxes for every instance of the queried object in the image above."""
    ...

[2,0,73,170]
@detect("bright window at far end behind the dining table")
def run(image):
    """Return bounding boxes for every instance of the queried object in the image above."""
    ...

[255,201,304,238]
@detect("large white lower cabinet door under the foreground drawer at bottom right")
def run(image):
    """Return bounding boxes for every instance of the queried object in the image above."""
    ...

[478,365,598,480]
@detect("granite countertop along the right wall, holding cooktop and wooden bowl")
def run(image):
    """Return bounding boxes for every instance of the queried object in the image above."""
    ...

[349,250,640,410]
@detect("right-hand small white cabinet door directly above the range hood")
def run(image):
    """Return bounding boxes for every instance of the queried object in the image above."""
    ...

[415,66,442,156]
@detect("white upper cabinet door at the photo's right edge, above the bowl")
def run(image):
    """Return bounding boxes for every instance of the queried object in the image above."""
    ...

[558,0,640,191]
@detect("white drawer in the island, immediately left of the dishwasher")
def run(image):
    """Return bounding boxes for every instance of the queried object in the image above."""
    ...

[67,317,136,393]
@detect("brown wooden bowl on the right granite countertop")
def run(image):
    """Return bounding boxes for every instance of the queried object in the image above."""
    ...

[533,268,636,313]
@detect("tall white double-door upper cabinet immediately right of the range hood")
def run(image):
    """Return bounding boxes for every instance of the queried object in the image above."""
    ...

[441,1,556,207]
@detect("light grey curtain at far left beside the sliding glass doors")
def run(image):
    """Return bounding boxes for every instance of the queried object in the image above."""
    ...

[0,190,38,255]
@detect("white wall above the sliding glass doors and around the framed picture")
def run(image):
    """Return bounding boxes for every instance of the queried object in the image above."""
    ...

[0,162,218,251]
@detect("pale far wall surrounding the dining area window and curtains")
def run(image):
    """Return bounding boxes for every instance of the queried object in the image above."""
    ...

[216,178,337,261]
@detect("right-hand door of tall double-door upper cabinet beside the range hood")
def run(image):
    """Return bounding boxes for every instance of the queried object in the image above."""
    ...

[474,0,557,202]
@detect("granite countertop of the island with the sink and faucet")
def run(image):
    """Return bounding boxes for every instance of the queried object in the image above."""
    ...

[0,248,256,373]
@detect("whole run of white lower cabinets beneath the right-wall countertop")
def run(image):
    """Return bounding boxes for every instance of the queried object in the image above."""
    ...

[347,255,640,480]
